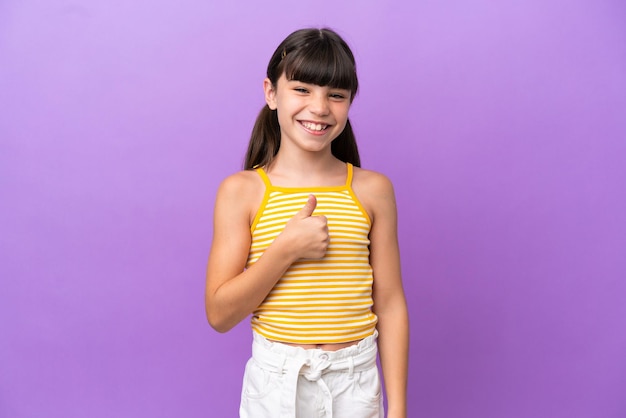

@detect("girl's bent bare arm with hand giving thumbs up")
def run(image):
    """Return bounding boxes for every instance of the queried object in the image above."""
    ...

[205,172,328,332]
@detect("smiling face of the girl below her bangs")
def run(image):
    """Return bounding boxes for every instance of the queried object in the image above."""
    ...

[264,74,350,155]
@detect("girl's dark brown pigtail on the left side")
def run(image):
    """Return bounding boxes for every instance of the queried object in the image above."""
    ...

[244,105,280,170]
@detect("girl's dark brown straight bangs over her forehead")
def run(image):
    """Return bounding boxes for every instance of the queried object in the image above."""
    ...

[284,39,358,94]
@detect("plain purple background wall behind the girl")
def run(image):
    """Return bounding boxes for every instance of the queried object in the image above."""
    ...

[0,0,626,418]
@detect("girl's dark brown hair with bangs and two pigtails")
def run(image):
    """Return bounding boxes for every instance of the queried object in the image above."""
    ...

[244,28,361,170]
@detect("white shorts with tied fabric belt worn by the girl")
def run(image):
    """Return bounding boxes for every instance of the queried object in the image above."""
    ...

[239,332,384,418]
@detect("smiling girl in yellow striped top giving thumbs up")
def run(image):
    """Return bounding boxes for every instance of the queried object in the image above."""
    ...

[206,29,409,418]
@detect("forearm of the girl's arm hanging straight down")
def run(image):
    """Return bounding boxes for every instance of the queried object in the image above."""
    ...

[377,300,409,418]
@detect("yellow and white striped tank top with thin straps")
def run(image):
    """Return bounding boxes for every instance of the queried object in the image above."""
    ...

[246,164,377,344]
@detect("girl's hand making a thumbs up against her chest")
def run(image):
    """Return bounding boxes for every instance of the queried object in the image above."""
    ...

[279,195,330,259]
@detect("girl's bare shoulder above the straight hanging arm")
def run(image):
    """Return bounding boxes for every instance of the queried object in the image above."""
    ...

[352,167,396,221]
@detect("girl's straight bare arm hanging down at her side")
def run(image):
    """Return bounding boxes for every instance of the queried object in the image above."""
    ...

[355,172,409,418]
